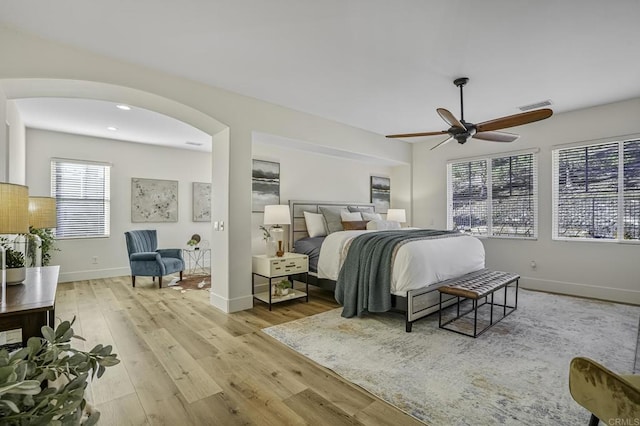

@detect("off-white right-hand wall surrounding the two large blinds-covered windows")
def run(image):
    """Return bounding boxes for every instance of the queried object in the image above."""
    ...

[413,99,640,304]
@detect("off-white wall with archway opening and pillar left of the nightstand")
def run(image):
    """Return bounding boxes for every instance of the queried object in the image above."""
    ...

[0,26,411,312]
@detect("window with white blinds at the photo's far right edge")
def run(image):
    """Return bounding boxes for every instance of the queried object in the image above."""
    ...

[553,140,640,241]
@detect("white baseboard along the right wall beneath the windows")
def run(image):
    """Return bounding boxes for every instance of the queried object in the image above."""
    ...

[520,276,640,305]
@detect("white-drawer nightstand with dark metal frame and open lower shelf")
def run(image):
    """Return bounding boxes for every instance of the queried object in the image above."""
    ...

[251,253,309,310]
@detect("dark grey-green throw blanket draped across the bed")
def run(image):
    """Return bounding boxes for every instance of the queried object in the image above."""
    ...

[335,229,460,318]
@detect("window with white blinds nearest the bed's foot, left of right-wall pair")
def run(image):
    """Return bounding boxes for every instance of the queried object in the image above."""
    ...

[447,152,538,238]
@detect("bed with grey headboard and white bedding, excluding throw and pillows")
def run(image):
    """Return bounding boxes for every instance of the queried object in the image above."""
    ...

[289,200,485,332]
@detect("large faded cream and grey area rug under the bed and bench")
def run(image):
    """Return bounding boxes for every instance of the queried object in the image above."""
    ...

[263,290,640,426]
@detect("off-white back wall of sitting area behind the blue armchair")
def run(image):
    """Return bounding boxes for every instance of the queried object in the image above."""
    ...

[27,129,211,282]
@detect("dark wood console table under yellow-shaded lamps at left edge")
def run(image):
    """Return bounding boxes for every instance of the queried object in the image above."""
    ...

[0,266,60,346]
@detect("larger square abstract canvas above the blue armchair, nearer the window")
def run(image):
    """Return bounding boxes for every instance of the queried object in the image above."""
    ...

[131,178,178,223]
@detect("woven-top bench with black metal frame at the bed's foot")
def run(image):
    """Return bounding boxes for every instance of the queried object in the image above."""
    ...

[438,269,520,337]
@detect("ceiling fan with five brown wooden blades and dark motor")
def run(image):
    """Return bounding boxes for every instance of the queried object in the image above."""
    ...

[387,77,553,149]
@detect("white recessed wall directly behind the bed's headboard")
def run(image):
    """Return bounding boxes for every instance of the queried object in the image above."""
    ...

[251,143,401,254]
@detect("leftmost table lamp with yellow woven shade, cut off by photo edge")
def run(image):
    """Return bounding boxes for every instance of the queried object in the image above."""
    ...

[0,182,29,305]
